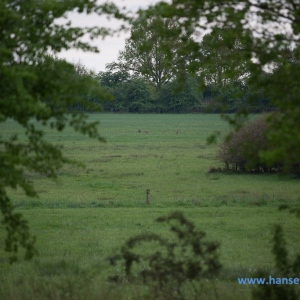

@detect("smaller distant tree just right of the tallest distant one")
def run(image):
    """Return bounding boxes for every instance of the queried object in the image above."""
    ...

[197,29,251,111]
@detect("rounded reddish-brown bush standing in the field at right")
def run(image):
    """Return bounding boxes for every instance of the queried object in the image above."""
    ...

[218,116,283,173]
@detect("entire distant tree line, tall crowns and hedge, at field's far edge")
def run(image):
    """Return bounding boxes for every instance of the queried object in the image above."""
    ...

[72,17,274,113]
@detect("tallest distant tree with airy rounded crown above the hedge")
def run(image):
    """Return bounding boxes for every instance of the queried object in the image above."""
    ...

[106,16,187,88]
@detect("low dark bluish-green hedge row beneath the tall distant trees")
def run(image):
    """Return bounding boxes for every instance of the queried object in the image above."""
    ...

[92,71,273,113]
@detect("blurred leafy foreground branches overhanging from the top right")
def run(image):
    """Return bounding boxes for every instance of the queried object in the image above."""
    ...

[135,0,300,170]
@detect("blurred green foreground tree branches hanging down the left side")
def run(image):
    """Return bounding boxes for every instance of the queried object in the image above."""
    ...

[0,0,119,261]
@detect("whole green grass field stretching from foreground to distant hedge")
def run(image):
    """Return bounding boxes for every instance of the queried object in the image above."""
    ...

[0,114,300,299]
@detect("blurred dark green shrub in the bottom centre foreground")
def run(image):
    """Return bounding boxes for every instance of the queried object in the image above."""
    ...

[110,212,221,299]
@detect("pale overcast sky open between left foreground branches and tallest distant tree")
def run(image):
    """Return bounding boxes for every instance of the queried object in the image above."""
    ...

[58,0,159,73]
